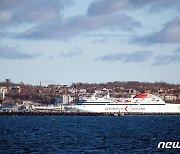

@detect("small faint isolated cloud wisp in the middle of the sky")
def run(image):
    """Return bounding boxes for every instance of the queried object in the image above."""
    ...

[60,48,83,58]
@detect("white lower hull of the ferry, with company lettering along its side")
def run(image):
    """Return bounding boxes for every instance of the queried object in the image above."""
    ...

[66,104,180,113]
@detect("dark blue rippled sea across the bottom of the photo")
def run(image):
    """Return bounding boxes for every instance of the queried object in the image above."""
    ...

[0,115,180,154]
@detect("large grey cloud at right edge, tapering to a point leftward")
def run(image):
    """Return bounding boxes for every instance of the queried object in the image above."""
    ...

[132,17,180,44]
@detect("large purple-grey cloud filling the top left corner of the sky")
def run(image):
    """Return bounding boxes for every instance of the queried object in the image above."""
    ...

[0,0,69,27]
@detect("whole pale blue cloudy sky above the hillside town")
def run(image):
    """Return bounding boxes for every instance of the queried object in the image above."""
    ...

[0,0,180,85]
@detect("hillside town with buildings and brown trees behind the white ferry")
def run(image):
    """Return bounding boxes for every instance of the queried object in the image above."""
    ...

[0,79,180,112]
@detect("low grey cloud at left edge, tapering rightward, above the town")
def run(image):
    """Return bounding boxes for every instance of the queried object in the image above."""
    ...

[0,46,41,60]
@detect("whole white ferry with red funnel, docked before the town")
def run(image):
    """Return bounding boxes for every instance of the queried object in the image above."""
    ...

[64,92,180,113]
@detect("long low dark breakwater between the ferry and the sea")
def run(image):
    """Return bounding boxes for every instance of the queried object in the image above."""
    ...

[0,112,180,116]
